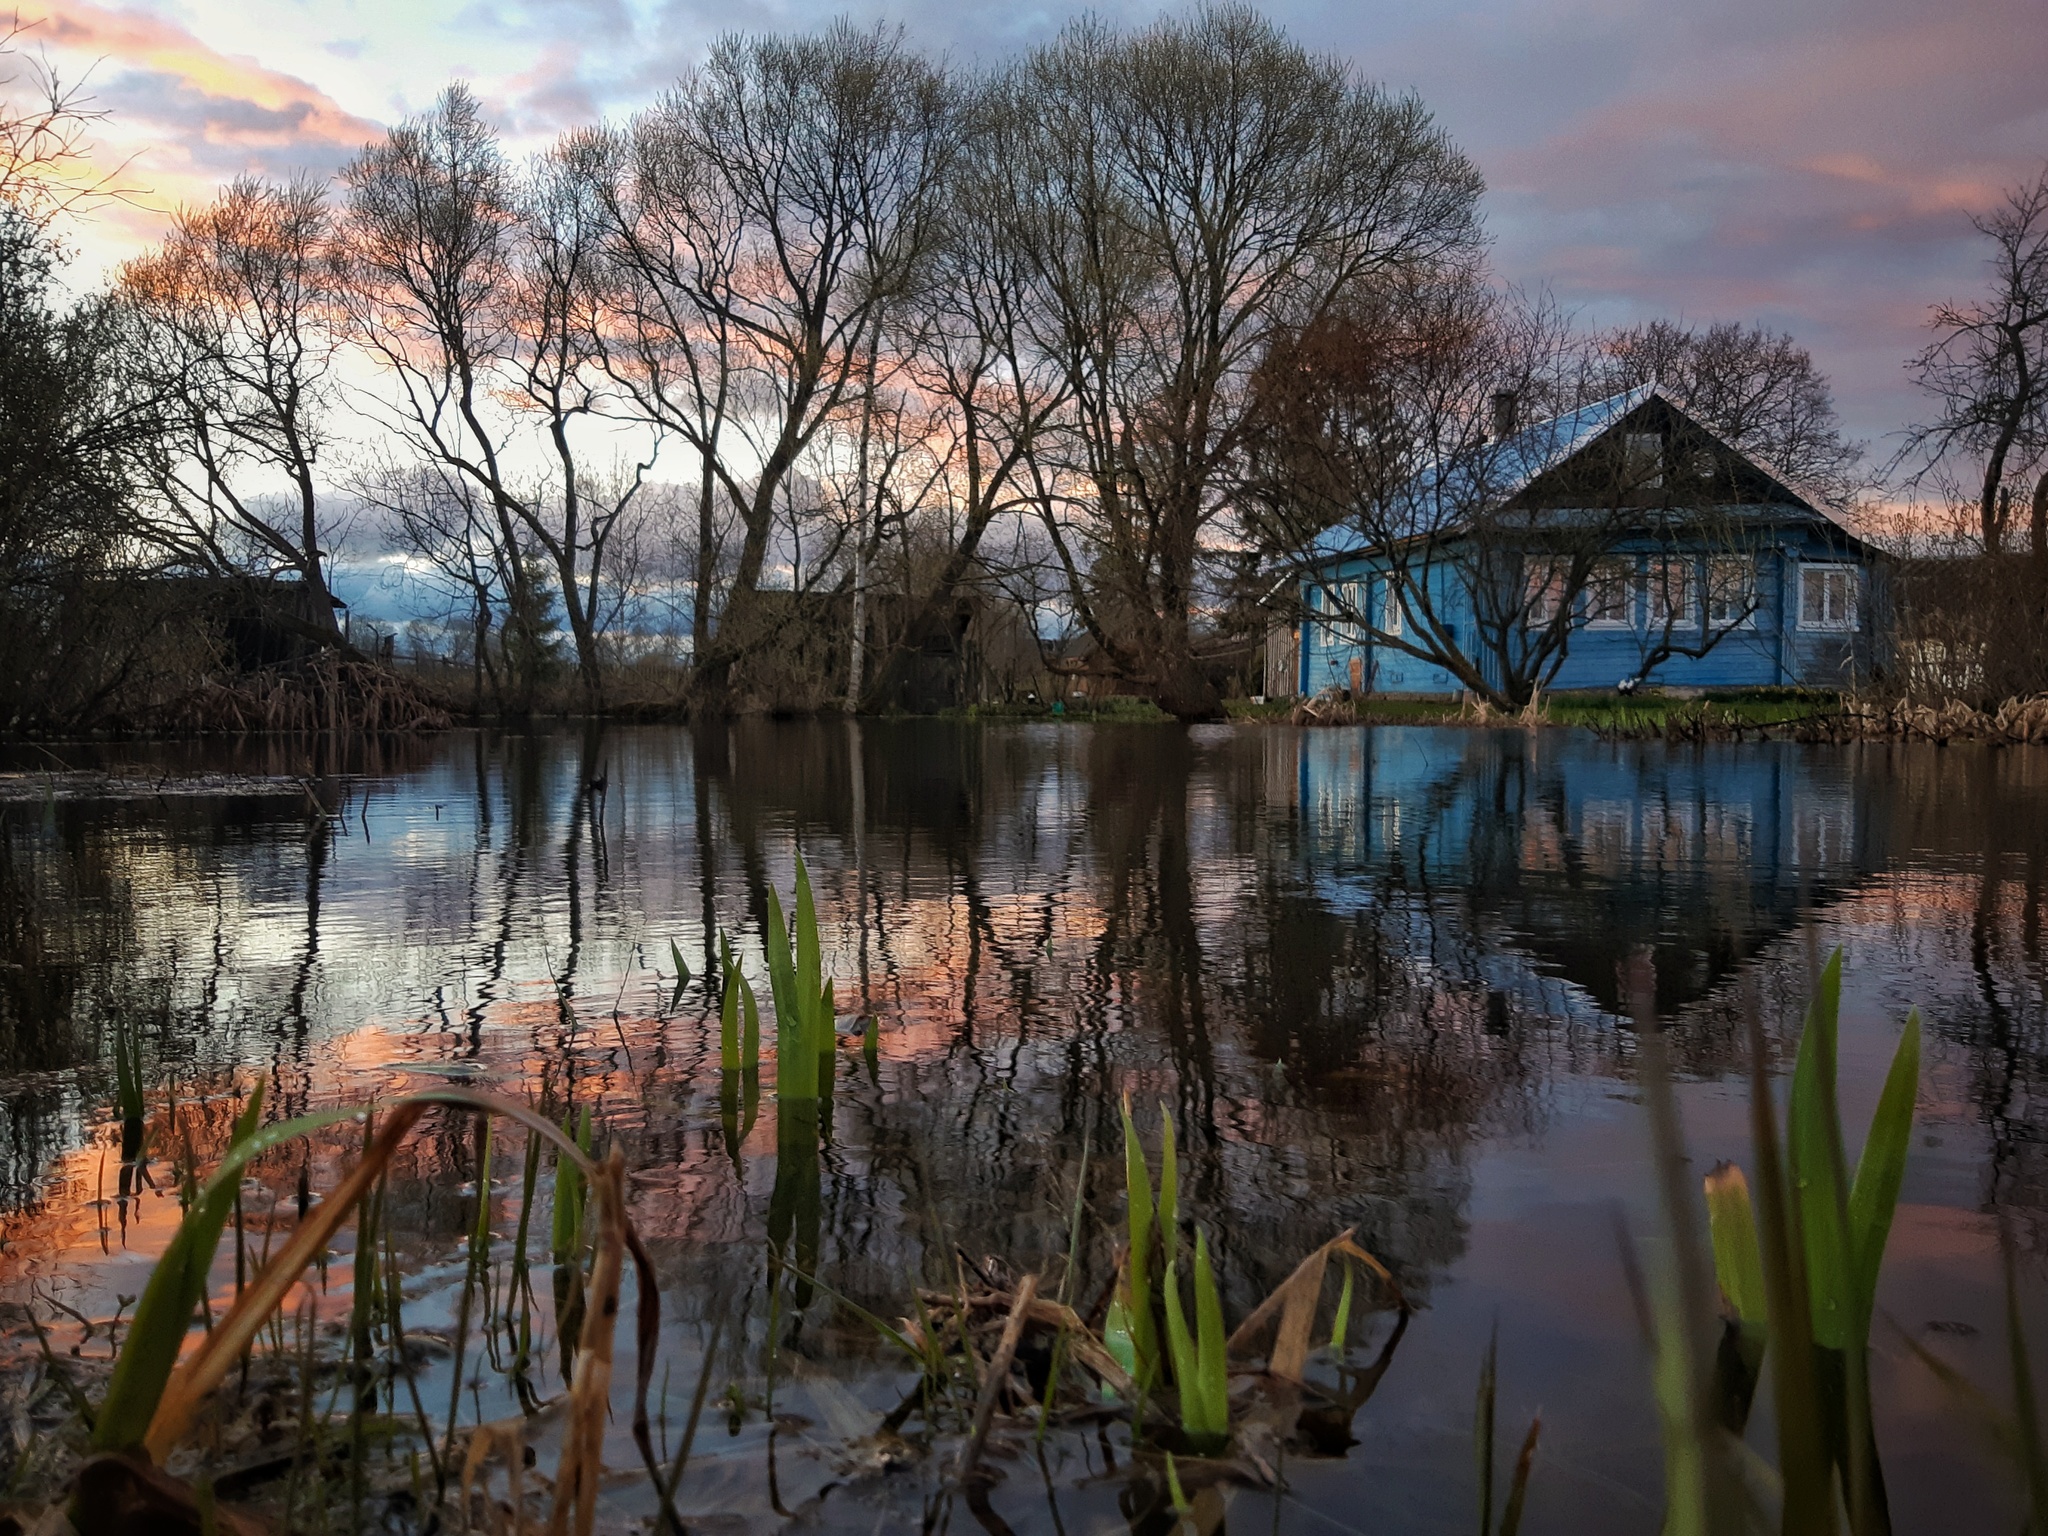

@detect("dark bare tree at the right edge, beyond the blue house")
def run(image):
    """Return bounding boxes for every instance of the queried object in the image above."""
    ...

[1894,166,2048,555]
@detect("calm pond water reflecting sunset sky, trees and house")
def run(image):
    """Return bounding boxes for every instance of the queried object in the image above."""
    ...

[0,723,2048,1532]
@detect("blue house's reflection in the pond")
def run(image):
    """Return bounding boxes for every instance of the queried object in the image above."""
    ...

[1292,729,1882,1016]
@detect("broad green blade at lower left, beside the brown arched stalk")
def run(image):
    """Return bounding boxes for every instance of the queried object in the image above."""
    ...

[92,1083,268,1450]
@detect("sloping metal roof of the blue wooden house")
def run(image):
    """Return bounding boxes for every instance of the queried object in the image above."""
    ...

[1309,381,1862,563]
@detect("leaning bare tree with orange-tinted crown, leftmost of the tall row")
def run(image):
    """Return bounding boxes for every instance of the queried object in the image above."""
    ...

[119,176,340,641]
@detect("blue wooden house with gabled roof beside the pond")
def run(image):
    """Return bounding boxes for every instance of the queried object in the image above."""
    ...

[1268,383,1882,696]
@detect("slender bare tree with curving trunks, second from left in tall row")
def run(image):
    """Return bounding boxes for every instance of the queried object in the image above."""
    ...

[344,86,647,709]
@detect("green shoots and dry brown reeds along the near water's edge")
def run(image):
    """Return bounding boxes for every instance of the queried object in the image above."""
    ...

[0,860,2023,1536]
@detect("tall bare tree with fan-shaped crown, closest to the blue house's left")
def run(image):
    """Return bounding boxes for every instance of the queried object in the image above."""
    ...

[985,6,1481,719]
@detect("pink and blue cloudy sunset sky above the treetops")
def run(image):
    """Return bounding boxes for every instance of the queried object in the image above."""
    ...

[18,0,2048,457]
